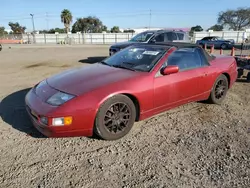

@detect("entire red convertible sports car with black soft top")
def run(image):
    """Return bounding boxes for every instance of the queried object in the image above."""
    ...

[25,43,237,140]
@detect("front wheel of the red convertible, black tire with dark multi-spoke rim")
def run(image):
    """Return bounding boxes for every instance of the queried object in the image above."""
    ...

[94,94,136,140]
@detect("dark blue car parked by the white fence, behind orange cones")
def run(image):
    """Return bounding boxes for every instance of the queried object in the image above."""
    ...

[196,36,235,49]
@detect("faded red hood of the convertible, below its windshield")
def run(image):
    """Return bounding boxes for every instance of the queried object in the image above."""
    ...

[47,63,142,95]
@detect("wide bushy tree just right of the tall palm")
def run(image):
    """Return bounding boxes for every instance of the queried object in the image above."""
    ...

[72,16,105,33]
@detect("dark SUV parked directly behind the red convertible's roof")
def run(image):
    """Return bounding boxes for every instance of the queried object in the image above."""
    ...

[109,30,191,56]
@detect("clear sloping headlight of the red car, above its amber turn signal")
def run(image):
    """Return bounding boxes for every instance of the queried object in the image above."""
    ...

[47,92,75,106]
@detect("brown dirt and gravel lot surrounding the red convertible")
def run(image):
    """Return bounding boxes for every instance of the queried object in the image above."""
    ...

[0,46,250,188]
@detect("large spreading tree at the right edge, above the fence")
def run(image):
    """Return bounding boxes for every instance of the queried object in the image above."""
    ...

[218,8,250,31]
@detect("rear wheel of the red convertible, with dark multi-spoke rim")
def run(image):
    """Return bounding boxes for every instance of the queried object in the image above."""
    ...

[208,74,228,104]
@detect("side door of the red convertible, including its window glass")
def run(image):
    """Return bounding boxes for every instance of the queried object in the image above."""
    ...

[154,48,206,109]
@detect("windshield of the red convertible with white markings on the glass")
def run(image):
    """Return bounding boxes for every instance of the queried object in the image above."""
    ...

[102,46,167,72]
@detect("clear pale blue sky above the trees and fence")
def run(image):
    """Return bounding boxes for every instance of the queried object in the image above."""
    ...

[0,0,250,31]
